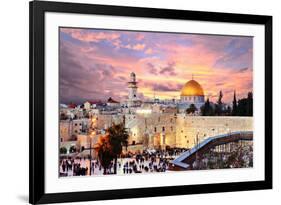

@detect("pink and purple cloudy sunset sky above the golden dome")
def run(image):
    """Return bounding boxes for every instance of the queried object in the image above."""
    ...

[59,28,253,103]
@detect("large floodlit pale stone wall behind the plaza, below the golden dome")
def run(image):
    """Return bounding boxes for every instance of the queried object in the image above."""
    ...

[126,113,253,148]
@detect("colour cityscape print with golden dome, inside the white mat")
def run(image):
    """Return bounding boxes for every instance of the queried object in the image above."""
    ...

[57,27,255,177]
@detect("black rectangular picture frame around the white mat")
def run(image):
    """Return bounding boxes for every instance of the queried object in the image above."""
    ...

[29,1,272,204]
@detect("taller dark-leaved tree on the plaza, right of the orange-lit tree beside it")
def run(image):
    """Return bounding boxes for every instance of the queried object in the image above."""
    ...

[107,123,129,174]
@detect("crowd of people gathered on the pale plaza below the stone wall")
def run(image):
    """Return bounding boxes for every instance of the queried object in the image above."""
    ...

[60,148,186,176]
